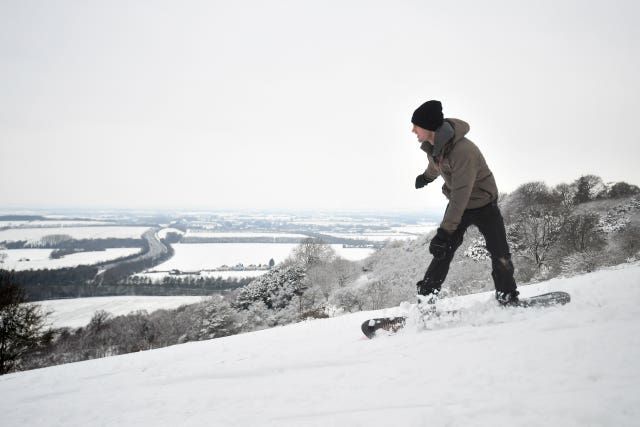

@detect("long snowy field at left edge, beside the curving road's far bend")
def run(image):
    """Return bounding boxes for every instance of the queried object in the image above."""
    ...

[0,226,149,242]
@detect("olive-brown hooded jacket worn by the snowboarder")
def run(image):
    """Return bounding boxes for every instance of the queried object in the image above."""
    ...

[420,119,498,233]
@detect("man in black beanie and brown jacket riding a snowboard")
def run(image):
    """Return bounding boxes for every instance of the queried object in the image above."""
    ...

[411,100,519,305]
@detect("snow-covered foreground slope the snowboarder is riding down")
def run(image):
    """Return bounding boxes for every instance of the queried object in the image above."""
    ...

[0,264,640,426]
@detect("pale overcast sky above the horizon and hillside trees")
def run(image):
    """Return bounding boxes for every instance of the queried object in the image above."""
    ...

[0,0,640,211]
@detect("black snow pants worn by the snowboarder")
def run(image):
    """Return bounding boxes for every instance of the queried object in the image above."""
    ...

[418,201,516,295]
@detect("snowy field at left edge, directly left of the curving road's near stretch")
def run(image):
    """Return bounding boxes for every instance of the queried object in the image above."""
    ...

[0,248,140,271]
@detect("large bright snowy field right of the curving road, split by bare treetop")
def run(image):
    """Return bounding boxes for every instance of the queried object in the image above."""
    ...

[148,243,373,271]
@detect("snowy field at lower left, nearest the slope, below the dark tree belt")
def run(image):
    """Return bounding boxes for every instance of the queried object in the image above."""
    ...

[38,296,208,328]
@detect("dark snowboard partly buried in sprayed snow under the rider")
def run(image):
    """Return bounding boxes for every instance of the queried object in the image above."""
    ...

[360,291,571,339]
